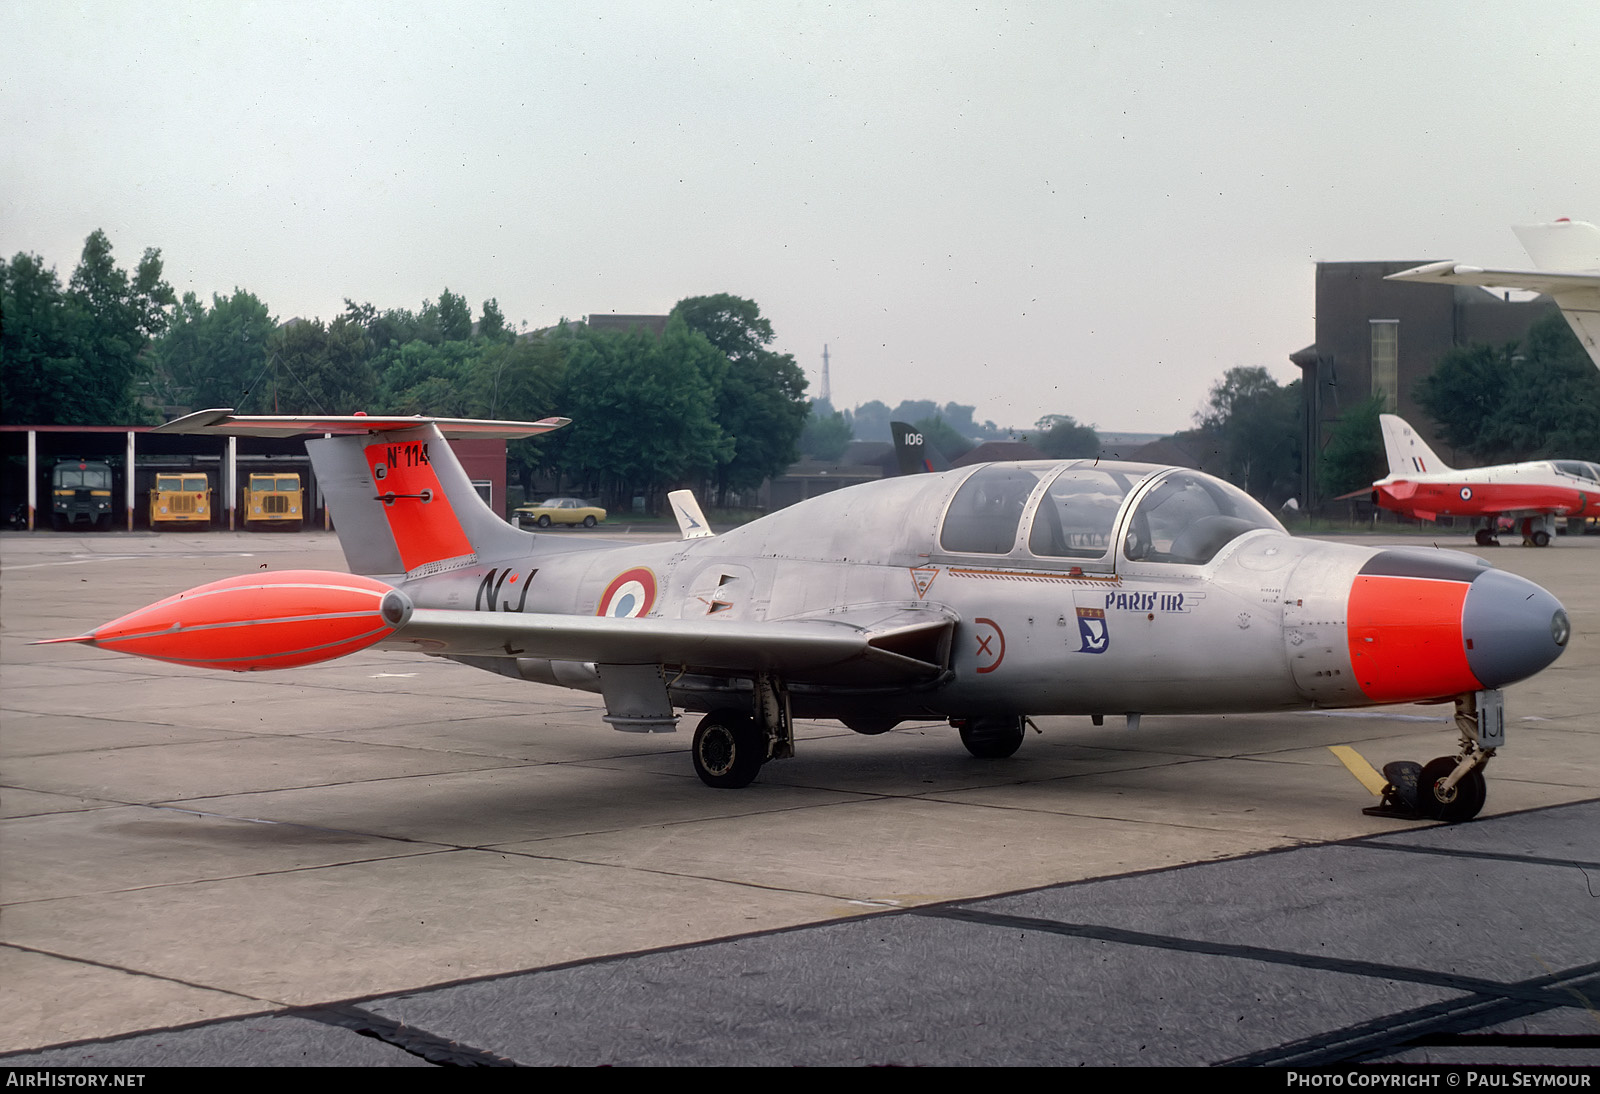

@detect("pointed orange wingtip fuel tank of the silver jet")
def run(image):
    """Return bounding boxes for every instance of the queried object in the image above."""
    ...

[48,569,411,672]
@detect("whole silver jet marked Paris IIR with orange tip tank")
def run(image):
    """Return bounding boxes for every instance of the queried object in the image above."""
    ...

[40,409,1570,821]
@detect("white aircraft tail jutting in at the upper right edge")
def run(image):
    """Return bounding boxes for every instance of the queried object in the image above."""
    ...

[1387,219,1600,368]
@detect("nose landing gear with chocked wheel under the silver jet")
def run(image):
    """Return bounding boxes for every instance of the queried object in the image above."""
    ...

[1362,691,1506,824]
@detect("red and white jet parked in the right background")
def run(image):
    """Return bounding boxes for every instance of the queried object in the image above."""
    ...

[1357,414,1600,547]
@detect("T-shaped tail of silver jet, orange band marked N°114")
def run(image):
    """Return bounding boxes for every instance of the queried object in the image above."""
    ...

[152,411,566,577]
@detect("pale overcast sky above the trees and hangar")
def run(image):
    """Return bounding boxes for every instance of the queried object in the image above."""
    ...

[0,0,1600,432]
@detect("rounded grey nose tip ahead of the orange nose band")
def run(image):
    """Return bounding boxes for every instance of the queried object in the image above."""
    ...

[1461,569,1571,688]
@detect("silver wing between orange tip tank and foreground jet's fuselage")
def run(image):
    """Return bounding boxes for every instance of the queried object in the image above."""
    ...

[379,608,955,686]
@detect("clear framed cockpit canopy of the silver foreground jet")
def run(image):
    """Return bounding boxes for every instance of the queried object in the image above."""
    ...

[939,461,1283,565]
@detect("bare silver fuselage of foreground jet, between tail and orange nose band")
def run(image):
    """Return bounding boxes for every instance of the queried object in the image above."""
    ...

[403,475,1414,717]
